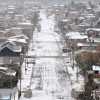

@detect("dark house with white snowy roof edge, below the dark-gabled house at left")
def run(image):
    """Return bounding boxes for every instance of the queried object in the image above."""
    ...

[0,66,18,88]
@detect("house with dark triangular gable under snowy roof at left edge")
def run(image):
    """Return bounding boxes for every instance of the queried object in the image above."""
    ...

[0,41,22,65]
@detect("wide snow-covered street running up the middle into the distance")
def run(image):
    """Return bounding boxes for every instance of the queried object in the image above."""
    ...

[21,11,73,100]
